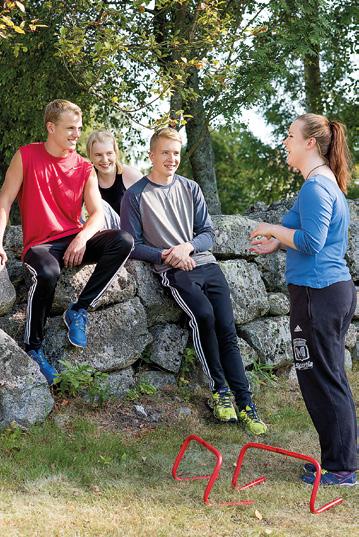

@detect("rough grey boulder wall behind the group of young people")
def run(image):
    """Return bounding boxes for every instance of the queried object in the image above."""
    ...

[0,200,359,428]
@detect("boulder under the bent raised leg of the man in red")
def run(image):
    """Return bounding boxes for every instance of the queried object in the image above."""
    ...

[52,265,136,314]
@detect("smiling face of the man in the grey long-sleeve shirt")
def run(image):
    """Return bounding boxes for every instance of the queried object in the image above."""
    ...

[150,137,181,180]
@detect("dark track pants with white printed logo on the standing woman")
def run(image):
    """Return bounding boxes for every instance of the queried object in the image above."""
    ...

[288,280,357,471]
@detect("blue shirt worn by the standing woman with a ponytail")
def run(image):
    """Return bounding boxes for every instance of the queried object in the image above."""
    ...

[282,175,350,288]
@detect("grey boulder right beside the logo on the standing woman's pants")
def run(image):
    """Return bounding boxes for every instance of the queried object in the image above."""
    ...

[239,317,293,366]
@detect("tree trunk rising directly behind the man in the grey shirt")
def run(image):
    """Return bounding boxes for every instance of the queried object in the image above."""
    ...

[184,68,221,214]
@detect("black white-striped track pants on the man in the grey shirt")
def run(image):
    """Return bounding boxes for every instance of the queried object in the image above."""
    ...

[161,263,251,407]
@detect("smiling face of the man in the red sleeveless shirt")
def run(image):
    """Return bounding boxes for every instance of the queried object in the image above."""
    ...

[46,111,82,153]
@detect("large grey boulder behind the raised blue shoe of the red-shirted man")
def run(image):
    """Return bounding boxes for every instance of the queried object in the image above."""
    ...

[44,297,152,371]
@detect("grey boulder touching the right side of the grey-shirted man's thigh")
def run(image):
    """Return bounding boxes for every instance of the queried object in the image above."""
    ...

[219,259,269,325]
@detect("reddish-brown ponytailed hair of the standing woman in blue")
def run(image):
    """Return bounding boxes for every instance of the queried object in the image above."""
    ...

[297,114,351,194]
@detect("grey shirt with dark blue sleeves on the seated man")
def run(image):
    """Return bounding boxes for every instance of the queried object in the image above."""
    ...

[121,175,216,272]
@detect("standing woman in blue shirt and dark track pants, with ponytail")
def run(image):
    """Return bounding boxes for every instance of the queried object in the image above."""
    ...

[251,114,357,486]
